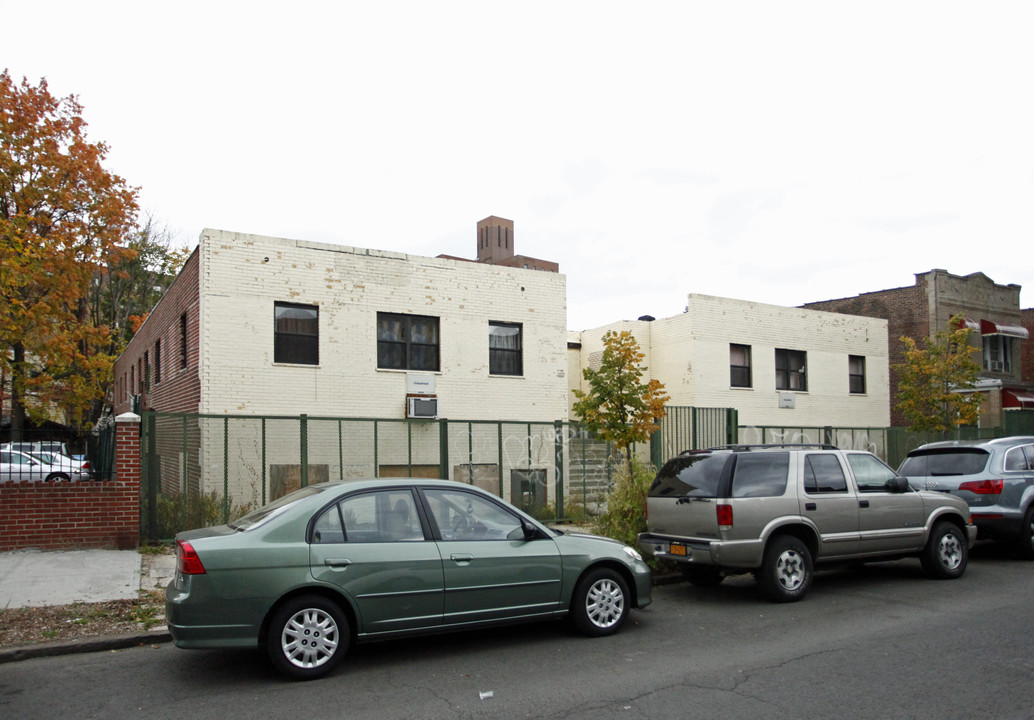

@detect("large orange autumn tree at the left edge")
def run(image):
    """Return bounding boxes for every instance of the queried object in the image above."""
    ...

[0,70,136,440]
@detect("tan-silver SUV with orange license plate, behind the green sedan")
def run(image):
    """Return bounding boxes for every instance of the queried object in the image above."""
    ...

[639,445,976,602]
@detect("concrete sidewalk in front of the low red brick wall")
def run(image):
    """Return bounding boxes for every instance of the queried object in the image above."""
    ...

[0,550,176,607]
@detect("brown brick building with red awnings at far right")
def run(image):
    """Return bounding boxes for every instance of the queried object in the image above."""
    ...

[801,269,1034,427]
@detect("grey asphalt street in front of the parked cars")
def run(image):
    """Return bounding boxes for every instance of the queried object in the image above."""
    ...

[0,547,1034,720]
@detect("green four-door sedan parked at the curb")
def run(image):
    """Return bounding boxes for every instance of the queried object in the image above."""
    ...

[165,479,650,680]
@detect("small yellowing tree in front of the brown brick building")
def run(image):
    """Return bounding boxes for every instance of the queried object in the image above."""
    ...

[893,316,981,432]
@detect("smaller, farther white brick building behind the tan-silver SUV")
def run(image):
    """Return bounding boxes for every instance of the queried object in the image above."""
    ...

[568,294,889,427]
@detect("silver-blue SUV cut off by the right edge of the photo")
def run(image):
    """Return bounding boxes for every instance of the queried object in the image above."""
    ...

[898,437,1034,560]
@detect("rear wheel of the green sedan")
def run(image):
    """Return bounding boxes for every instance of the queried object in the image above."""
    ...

[266,595,352,680]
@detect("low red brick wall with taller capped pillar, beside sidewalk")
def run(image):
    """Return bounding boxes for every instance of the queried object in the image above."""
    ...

[0,413,140,551]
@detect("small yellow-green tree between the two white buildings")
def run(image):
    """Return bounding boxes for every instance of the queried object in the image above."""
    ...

[574,330,669,477]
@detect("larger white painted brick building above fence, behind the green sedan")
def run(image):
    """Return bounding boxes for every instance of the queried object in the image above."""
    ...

[122,230,568,422]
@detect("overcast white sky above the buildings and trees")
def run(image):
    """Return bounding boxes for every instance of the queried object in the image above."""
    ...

[8,0,1034,329]
